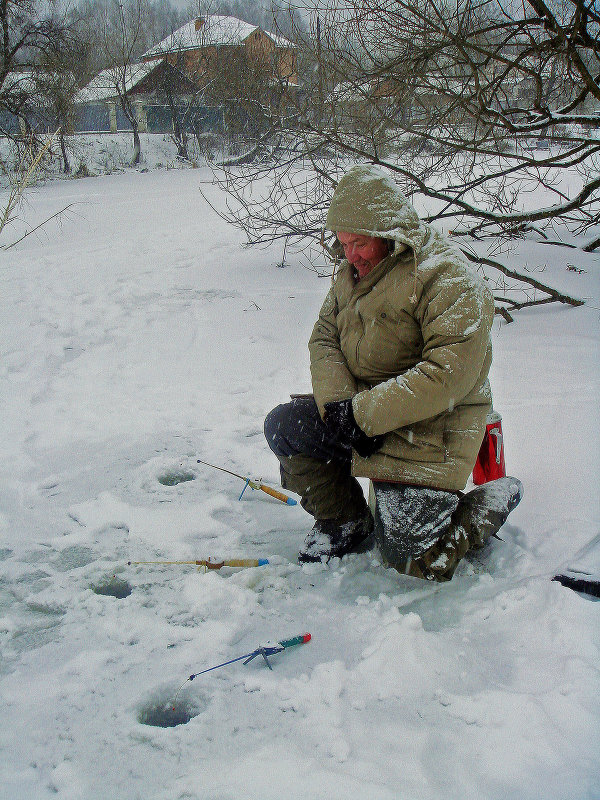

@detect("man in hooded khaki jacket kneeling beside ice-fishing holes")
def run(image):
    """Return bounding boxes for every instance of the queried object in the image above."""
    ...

[265,165,522,580]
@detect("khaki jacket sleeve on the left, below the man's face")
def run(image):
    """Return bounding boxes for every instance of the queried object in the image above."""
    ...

[308,287,357,416]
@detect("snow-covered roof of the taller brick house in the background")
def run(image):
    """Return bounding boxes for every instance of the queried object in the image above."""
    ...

[143,14,295,58]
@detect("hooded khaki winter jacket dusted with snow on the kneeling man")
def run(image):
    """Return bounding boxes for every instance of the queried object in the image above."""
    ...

[309,166,494,491]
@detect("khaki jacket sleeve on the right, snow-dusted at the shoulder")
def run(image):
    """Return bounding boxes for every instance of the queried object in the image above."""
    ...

[352,270,494,436]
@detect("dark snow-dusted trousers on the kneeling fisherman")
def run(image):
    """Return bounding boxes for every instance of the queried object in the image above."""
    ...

[264,397,468,579]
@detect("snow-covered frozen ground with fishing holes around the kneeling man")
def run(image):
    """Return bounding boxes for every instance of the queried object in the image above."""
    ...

[0,155,600,800]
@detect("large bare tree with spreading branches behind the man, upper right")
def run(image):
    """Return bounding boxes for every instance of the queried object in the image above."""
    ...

[207,0,600,318]
